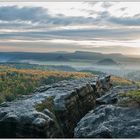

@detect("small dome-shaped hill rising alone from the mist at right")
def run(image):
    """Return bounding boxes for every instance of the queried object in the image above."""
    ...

[97,58,118,65]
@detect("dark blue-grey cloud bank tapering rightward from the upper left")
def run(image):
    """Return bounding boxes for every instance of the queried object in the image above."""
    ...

[0,6,97,26]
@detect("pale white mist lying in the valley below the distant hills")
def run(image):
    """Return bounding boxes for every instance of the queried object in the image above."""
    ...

[17,56,140,80]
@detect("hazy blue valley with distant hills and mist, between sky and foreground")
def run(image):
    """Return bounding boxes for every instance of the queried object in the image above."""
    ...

[0,51,140,80]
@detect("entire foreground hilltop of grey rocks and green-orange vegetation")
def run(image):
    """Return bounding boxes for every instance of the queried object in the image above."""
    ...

[0,63,140,138]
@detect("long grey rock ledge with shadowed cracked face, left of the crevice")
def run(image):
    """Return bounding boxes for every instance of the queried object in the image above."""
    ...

[0,77,111,138]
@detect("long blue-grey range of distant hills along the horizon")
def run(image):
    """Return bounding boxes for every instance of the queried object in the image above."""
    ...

[0,51,140,62]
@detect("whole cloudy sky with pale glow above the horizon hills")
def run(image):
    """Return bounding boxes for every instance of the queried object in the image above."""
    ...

[0,2,140,55]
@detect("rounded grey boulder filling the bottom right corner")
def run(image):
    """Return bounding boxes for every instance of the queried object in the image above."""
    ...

[75,105,140,138]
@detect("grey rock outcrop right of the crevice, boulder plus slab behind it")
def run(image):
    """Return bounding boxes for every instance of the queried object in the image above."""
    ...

[74,86,140,138]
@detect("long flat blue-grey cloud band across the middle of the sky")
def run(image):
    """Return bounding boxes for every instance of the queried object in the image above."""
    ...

[0,28,140,40]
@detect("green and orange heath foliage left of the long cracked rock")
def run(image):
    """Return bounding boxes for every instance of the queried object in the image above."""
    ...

[0,65,93,103]
